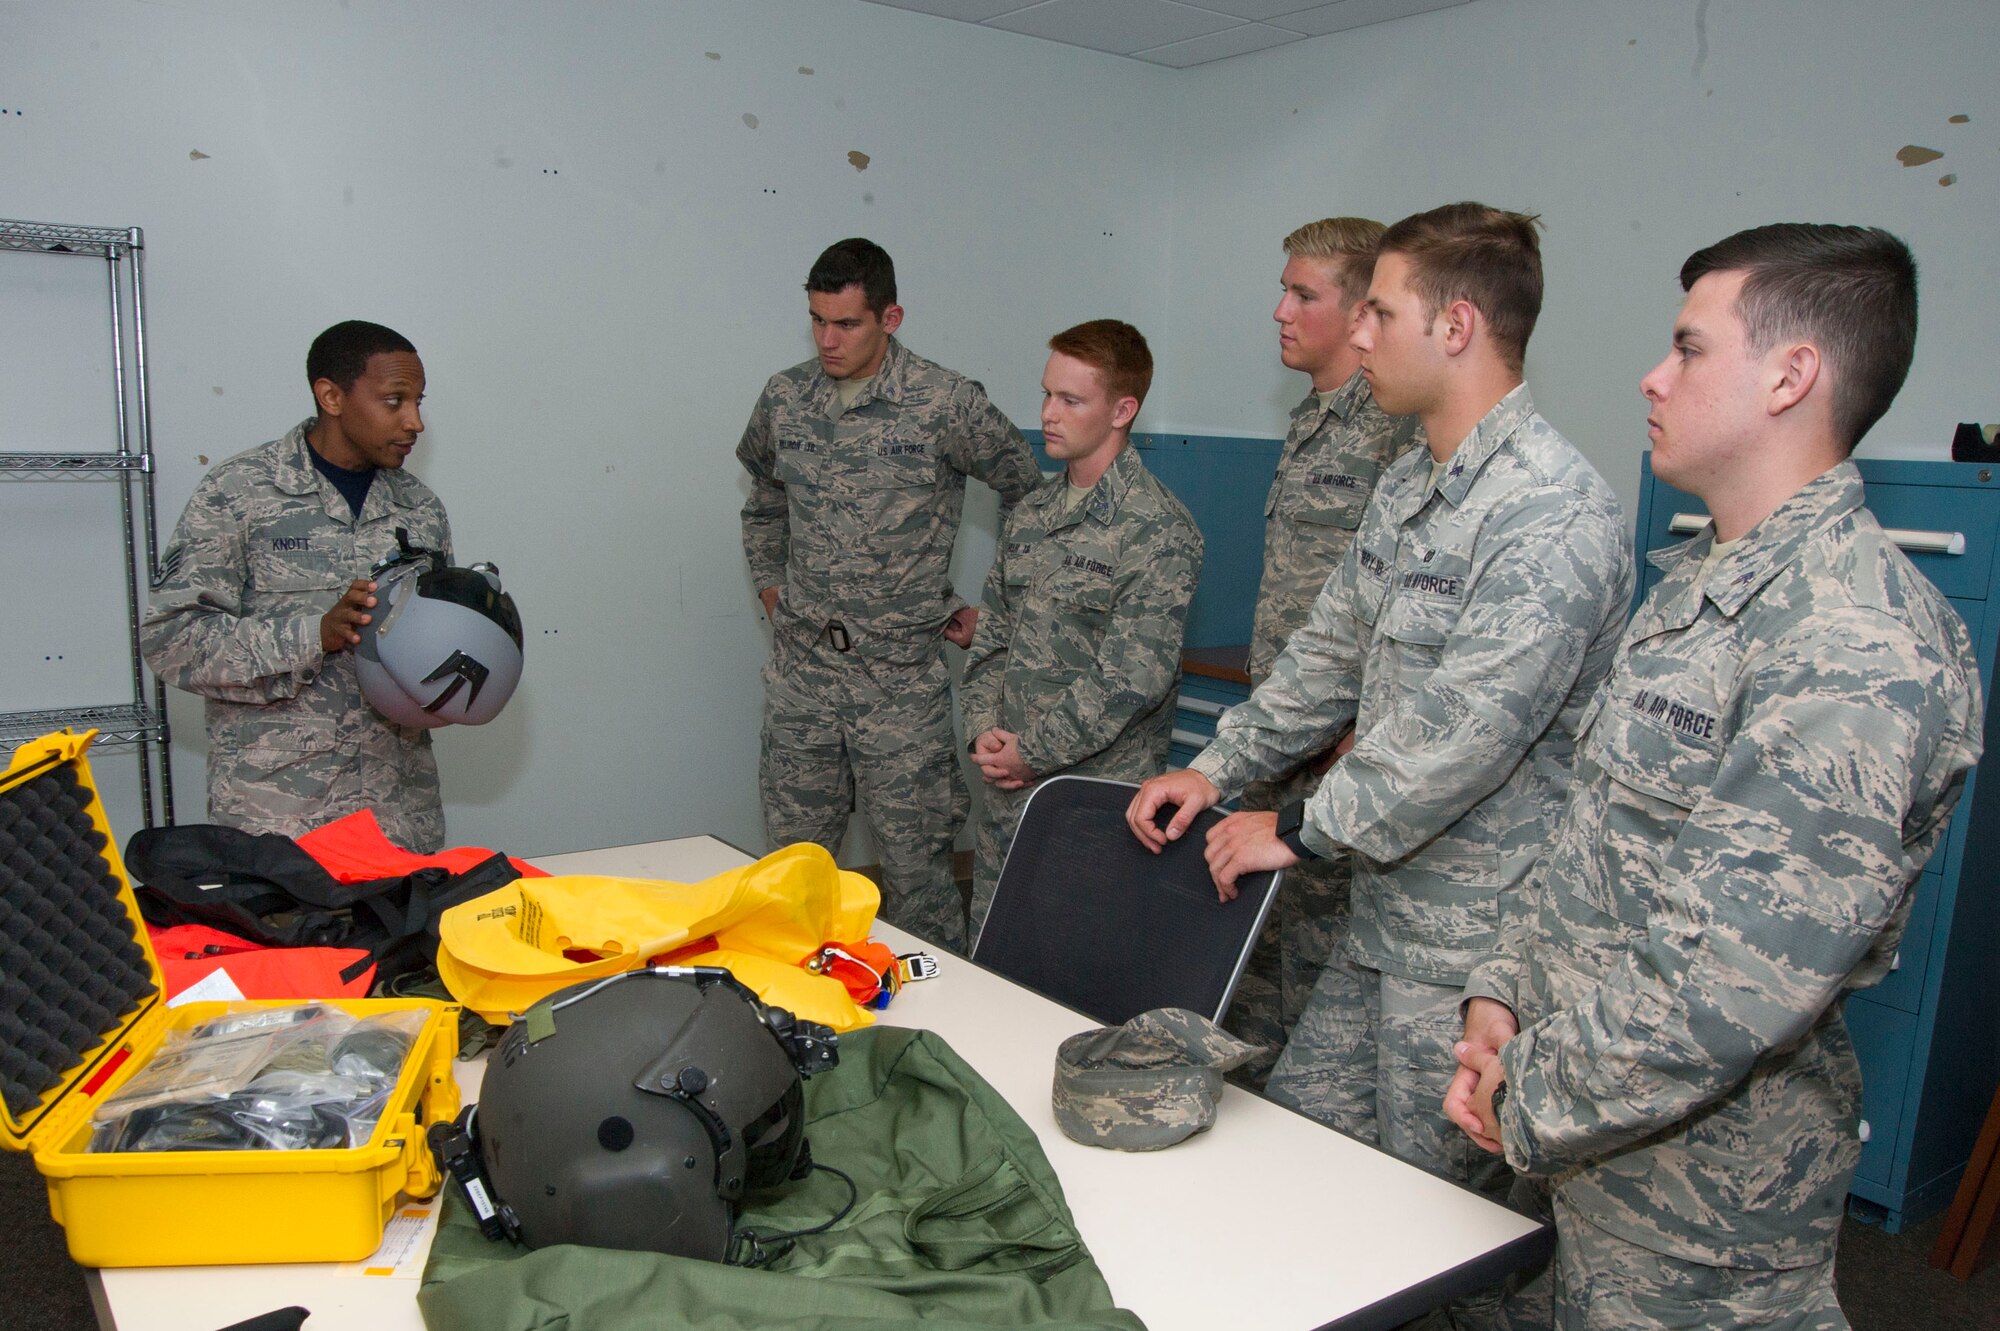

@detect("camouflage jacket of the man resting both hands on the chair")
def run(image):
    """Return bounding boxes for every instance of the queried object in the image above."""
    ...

[1192,386,1632,983]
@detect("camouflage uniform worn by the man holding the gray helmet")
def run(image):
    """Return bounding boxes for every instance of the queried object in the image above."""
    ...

[140,420,452,853]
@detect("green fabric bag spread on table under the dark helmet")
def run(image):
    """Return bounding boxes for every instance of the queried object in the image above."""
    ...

[416,1027,1144,1331]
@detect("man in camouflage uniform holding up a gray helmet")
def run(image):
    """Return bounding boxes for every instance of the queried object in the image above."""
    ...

[140,320,452,851]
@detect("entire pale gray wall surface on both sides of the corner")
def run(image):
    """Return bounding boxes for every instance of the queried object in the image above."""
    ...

[0,0,2000,859]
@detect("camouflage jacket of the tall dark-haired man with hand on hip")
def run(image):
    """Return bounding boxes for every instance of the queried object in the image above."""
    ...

[736,338,1040,666]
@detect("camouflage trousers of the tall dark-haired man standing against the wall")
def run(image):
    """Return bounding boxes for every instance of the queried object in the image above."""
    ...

[758,638,970,953]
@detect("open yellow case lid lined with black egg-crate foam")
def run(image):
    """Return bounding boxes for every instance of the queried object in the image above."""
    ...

[0,729,166,1151]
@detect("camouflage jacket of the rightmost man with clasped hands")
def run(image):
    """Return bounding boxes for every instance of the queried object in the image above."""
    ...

[1468,464,1980,1267]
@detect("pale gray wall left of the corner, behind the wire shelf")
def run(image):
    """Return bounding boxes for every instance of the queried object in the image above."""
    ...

[0,0,1172,855]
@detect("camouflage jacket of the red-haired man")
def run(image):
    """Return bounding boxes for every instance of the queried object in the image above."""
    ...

[960,446,1202,779]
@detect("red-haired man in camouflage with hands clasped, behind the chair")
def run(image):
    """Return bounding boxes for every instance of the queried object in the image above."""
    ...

[962,320,1202,935]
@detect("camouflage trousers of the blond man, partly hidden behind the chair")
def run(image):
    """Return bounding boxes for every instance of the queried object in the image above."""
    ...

[1222,771,1374,1087]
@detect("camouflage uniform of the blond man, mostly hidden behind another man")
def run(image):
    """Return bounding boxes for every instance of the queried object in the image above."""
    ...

[1226,370,1422,1095]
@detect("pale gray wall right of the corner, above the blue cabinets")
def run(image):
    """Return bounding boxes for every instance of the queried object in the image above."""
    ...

[1154,0,2000,508]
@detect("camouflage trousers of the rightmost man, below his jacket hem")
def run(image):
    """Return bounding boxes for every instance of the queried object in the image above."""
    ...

[1500,1179,1848,1331]
